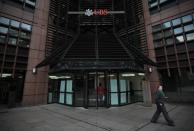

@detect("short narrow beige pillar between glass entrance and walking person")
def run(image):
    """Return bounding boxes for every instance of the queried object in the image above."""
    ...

[142,80,152,106]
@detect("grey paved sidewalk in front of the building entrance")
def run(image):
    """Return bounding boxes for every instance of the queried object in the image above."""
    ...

[0,103,194,131]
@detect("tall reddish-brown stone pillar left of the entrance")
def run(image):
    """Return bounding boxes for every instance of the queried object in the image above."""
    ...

[22,0,49,105]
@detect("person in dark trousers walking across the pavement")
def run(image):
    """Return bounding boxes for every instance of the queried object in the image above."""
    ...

[151,85,175,126]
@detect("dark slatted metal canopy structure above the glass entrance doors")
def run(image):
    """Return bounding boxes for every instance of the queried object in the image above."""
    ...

[36,0,156,71]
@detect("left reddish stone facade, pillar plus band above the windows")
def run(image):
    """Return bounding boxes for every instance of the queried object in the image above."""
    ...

[0,0,49,106]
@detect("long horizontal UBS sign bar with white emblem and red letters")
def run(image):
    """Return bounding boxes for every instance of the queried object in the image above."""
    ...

[68,9,125,16]
